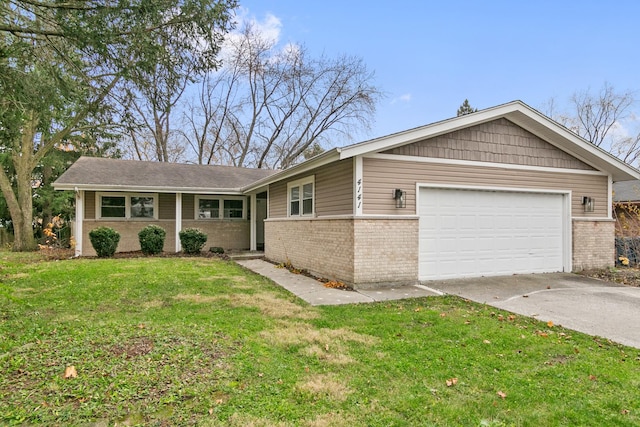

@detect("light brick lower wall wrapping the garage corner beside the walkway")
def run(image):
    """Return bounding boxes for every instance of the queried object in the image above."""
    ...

[265,218,418,288]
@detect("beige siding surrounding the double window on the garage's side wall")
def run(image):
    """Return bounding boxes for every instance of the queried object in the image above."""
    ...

[269,159,353,218]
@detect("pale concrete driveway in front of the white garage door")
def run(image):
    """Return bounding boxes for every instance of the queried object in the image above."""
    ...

[423,273,640,348]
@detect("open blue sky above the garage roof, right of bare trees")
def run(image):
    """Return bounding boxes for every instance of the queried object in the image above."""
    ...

[235,0,640,145]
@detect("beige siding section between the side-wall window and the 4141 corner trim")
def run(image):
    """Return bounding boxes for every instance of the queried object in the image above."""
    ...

[315,159,353,217]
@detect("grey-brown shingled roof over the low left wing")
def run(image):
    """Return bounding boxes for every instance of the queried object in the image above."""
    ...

[54,157,277,193]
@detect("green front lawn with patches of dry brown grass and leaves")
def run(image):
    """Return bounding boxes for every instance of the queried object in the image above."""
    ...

[0,252,640,426]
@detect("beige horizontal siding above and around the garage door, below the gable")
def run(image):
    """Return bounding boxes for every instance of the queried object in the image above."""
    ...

[363,158,608,218]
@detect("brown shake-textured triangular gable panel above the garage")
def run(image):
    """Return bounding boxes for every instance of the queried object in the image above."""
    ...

[383,119,593,170]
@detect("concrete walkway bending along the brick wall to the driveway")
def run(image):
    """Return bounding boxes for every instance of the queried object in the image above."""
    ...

[236,259,442,305]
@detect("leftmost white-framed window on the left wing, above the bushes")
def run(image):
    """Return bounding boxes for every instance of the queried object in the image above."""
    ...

[96,193,158,219]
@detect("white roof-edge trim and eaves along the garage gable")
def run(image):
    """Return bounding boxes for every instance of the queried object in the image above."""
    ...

[247,101,640,190]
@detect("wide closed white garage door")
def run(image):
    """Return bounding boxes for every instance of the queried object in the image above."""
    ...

[419,188,565,280]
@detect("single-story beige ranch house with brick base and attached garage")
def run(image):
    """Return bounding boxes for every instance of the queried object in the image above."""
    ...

[55,101,640,287]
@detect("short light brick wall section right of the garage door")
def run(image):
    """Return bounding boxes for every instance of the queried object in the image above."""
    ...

[572,219,615,271]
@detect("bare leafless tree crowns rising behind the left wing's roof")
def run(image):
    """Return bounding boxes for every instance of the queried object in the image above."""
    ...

[185,25,381,168]
